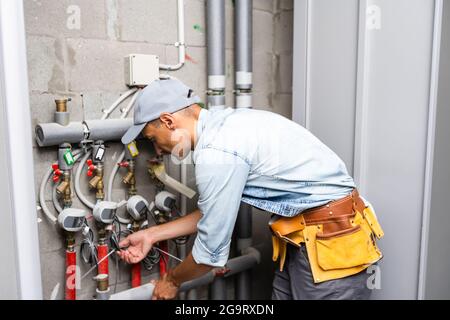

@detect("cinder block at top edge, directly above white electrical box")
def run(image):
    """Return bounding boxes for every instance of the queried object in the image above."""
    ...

[119,0,177,44]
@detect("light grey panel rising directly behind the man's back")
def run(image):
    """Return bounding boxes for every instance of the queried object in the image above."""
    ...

[308,0,358,172]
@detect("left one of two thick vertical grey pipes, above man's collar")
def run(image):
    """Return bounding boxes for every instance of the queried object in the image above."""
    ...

[206,0,225,108]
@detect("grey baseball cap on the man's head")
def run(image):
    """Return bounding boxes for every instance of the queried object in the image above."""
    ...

[122,78,200,144]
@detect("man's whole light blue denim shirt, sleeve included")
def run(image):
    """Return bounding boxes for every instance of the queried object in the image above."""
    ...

[192,108,355,267]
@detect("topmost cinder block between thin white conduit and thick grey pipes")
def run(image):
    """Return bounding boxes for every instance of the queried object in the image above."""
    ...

[185,0,206,47]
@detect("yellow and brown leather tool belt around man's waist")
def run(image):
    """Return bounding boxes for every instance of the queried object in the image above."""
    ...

[269,189,384,283]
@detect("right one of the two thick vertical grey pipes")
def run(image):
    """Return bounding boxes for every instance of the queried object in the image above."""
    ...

[236,0,253,300]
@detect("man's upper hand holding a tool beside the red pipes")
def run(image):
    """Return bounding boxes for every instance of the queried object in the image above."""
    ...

[117,230,153,264]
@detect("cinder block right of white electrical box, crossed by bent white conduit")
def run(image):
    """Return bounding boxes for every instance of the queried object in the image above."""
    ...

[164,46,207,101]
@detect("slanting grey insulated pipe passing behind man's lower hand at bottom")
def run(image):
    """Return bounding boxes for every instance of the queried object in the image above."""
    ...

[110,247,261,300]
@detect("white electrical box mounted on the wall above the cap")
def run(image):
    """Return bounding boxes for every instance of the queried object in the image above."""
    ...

[125,54,159,87]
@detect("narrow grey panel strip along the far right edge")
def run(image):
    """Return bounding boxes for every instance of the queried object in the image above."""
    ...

[425,1,450,299]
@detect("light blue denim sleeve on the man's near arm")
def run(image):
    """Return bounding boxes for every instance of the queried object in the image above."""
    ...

[192,148,250,267]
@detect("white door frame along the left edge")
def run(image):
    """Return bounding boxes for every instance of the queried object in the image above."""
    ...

[0,0,42,299]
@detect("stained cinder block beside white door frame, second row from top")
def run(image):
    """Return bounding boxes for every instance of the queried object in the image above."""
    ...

[27,36,65,92]
